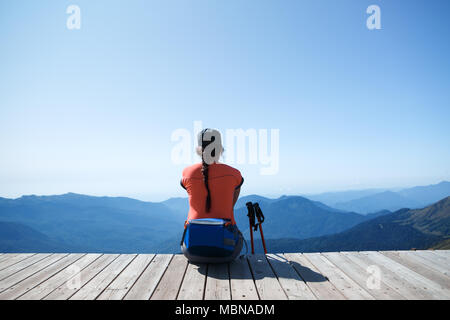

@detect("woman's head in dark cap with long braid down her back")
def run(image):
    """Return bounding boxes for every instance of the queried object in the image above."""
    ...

[197,128,223,212]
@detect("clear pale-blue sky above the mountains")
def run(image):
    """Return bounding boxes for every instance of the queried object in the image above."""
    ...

[0,0,450,200]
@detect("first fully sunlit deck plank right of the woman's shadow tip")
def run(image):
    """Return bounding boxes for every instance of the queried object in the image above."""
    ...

[304,253,374,300]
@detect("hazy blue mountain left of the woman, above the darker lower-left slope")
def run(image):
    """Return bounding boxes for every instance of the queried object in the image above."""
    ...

[0,193,184,253]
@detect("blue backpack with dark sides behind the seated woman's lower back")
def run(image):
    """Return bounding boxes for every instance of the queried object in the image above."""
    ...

[181,218,243,263]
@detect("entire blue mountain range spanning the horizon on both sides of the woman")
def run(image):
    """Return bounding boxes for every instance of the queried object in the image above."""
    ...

[0,182,450,253]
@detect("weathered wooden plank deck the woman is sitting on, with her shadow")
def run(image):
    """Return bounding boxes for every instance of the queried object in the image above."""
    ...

[0,250,450,300]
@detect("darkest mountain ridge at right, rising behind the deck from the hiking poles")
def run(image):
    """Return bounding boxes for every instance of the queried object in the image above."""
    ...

[257,197,450,252]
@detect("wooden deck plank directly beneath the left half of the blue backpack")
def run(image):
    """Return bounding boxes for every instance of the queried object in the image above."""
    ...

[177,263,207,300]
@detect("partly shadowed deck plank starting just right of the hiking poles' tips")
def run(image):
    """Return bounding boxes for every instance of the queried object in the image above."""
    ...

[267,254,317,300]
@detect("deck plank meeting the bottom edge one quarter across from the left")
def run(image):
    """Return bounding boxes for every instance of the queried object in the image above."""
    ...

[97,254,155,300]
